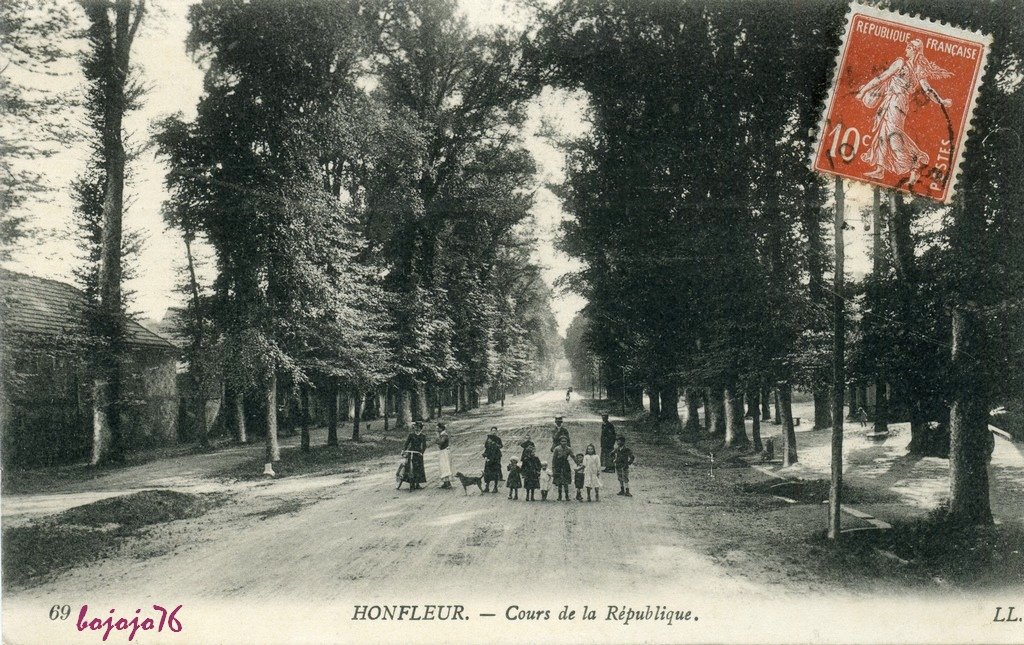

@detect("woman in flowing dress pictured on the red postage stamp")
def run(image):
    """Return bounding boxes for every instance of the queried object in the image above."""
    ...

[857,40,952,186]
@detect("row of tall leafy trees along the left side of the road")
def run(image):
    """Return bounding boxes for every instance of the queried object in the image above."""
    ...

[3,0,561,462]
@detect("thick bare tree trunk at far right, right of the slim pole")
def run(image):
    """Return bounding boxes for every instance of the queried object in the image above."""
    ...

[949,304,994,524]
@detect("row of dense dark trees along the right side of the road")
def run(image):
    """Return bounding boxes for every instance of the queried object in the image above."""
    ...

[537,0,1024,521]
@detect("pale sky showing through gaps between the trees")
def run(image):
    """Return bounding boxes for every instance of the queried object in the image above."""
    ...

[7,0,870,335]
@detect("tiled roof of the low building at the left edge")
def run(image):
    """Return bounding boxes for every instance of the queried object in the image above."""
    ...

[0,268,176,350]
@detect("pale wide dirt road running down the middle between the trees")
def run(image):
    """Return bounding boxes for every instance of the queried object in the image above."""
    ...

[4,392,752,600]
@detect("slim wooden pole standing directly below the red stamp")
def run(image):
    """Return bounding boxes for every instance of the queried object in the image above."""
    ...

[828,177,846,540]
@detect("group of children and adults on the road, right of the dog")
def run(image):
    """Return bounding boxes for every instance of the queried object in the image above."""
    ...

[483,418,634,502]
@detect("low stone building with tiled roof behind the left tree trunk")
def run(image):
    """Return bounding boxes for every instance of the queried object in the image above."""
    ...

[0,269,178,466]
